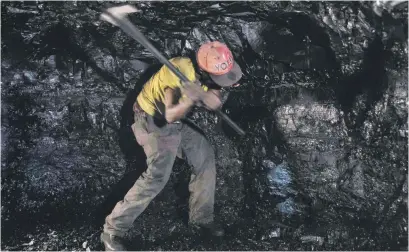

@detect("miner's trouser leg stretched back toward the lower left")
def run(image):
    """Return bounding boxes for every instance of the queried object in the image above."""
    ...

[104,117,181,246]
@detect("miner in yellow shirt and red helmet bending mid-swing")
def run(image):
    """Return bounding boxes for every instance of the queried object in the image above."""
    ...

[101,41,242,250]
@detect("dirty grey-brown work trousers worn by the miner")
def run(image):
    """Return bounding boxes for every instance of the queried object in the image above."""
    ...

[104,112,216,236]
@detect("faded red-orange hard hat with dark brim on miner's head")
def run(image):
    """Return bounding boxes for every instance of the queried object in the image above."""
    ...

[196,41,243,87]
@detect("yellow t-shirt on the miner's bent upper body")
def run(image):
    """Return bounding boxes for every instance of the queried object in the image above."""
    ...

[136,57,207,116]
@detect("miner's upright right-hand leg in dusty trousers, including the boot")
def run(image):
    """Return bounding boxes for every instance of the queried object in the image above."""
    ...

[181,124,223,236]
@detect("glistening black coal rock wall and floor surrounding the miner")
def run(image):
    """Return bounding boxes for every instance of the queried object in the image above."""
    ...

[1,2,408,250]
